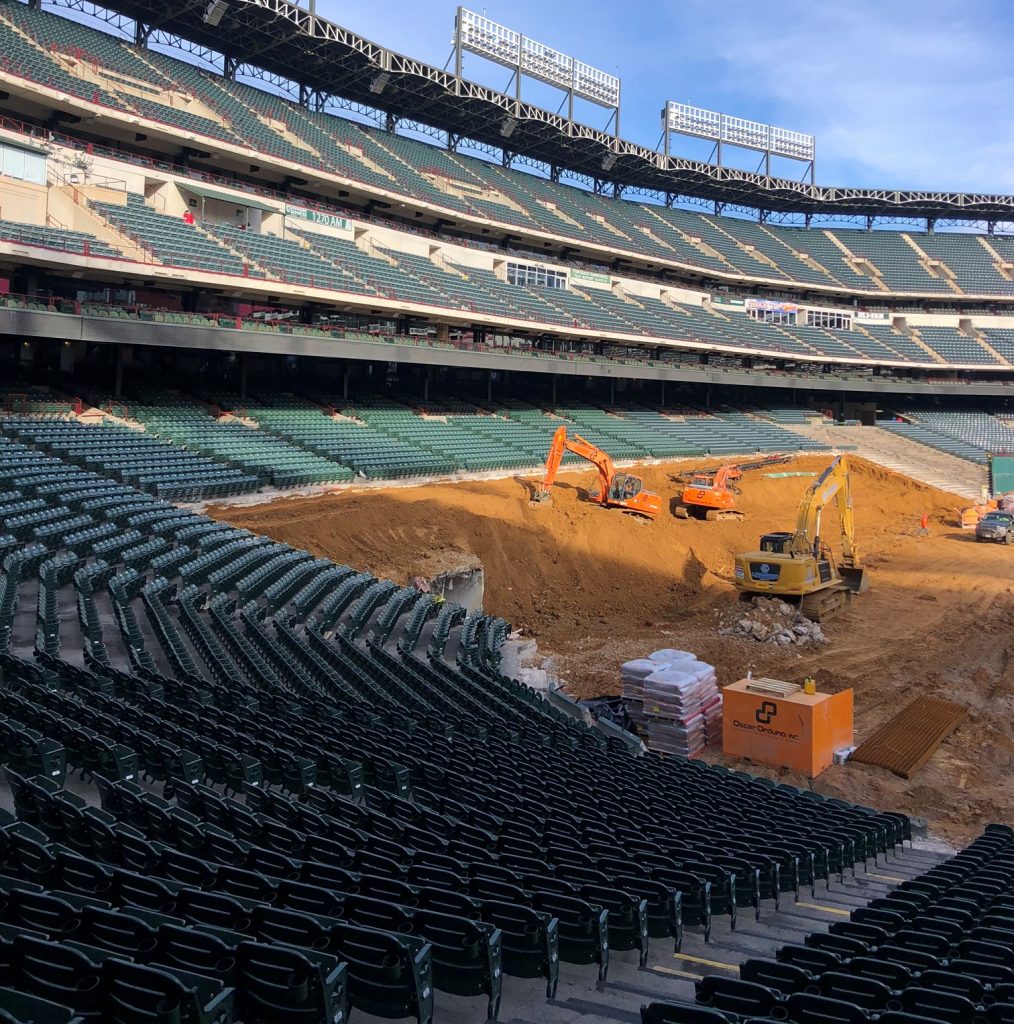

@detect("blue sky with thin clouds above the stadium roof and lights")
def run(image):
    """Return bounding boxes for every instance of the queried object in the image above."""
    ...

[318,0,1014,194]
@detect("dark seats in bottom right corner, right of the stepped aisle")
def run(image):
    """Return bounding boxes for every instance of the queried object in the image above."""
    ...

[641,824,1014,1024]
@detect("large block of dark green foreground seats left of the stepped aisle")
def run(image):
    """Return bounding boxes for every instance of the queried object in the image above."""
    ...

[0,402,910,1022]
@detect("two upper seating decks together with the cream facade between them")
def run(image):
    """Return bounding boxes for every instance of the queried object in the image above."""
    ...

[0,0,1014,389]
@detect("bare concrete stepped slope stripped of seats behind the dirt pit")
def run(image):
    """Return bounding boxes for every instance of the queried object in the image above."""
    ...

[783,424,989,501]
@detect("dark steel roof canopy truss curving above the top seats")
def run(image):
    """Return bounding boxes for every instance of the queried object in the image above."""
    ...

[43,0,1014,228]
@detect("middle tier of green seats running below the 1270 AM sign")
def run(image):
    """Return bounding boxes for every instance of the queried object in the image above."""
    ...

[0,194,1008,367]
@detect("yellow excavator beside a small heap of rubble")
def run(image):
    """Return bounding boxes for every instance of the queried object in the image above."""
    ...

[735,456,867,622]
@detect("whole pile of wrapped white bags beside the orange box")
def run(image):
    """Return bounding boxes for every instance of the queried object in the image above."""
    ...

[621,650,722,758]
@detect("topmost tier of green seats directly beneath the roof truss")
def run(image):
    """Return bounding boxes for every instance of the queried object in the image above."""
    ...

[0,0,1014,300]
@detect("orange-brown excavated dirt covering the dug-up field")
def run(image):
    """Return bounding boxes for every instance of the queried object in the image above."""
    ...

[210,456,1014,842]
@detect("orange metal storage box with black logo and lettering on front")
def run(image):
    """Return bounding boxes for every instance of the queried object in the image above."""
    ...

[722,679,852,778]
